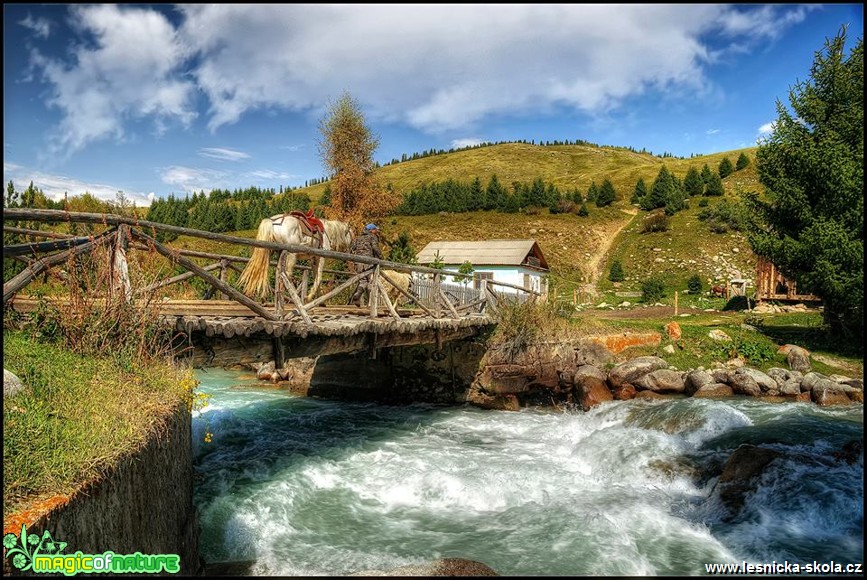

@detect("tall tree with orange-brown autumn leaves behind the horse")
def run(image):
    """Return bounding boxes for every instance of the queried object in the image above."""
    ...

[318,93,399,231]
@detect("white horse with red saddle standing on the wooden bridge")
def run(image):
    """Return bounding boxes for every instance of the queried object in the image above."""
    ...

[238,214,353,300]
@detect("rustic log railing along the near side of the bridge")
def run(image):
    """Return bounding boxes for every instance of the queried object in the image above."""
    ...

[3,208,540,322]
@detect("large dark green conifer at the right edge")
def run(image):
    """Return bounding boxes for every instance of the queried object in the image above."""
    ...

[746,27,864,344]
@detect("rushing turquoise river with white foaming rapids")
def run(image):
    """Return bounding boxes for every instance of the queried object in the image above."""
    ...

[193,369,864,576]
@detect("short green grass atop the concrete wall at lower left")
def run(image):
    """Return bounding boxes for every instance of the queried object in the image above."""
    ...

[3,329,196,519]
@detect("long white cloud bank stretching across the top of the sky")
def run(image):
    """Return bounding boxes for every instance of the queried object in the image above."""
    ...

[23,4,812,159]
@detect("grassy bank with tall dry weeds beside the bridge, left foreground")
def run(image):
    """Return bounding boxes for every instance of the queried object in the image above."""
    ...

[3,237,197,517]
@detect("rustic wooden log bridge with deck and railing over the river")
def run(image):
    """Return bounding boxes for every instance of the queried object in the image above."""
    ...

[3,208,538,365]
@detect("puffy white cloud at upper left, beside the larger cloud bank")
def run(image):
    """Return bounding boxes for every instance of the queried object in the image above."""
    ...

[32,4,195,156]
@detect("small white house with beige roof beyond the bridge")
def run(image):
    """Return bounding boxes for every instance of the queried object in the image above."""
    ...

[416,240,548,296]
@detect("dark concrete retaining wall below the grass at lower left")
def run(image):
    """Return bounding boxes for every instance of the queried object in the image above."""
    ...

[4,403,201,575]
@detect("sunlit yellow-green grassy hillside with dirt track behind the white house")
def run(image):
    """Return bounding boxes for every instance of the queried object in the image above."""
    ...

[290,143,762,292]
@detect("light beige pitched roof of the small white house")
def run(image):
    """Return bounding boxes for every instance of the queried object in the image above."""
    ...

[416,240,548,270]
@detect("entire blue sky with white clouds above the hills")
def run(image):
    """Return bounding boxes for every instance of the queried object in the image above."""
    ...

[3,4,863,206]
